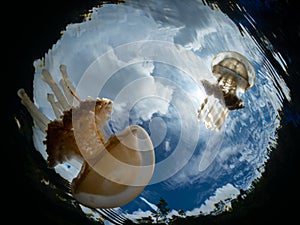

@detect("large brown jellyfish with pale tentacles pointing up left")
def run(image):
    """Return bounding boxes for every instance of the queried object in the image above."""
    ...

[18,65,155,208]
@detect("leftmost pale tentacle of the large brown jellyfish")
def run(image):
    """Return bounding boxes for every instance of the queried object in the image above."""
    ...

[17,88,50,132]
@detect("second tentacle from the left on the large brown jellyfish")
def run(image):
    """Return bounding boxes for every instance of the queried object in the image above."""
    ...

[42,69,71,111]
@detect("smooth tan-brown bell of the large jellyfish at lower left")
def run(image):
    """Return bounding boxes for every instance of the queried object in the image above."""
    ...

[72,126,154,208]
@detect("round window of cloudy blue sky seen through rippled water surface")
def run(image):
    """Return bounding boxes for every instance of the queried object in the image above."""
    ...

[10,0,297,224]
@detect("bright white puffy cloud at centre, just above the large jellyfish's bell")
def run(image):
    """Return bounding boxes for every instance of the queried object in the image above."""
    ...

[111,62,174,130]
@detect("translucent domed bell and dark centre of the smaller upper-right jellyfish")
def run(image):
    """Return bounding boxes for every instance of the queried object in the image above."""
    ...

[211,51,256,110]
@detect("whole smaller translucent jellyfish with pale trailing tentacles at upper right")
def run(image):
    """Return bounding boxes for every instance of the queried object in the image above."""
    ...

[198,51,256,130]
